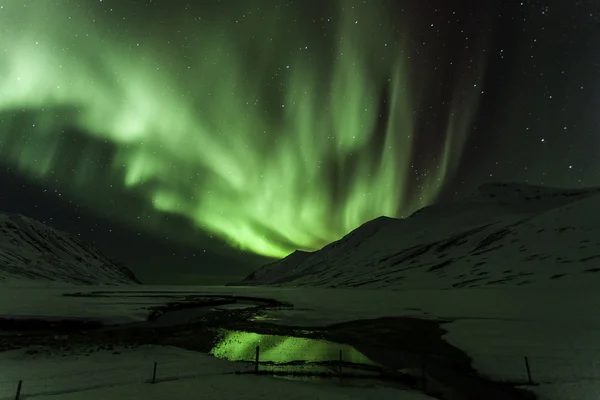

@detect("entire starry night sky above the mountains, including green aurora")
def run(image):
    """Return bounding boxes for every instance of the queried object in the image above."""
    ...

[0,0,600,284]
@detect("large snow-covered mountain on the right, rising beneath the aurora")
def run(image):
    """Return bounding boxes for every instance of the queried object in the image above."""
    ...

[231,183,600,290]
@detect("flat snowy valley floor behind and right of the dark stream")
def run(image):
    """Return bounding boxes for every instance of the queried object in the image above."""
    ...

[0,282,600,400]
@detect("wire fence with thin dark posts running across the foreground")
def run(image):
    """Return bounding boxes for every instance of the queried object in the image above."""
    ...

[0,346,600,400]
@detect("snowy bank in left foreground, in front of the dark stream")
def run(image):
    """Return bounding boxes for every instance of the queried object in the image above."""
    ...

[0,346,431,400]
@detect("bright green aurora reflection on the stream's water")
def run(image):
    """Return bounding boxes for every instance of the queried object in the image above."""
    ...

[210,331,376,365]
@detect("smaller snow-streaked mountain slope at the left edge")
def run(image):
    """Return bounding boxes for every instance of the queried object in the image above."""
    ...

[0,213,140,285]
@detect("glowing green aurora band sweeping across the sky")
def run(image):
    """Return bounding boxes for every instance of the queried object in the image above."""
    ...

[0,0,483,257]
